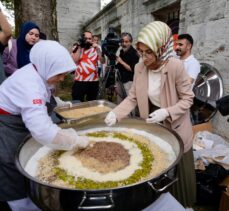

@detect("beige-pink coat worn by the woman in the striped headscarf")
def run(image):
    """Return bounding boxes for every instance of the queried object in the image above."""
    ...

[113,58,194,152]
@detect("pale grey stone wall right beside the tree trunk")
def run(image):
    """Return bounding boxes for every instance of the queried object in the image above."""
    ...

[57,0,100,48]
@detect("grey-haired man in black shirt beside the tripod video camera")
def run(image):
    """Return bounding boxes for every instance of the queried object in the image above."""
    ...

[116,32,139,104]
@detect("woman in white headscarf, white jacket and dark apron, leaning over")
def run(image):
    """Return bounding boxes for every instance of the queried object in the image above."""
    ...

[0,41,88,211]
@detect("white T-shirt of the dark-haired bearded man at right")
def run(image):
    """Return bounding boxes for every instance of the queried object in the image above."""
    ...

[182,55,200,82]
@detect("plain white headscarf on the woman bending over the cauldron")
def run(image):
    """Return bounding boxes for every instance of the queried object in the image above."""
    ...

[30,40,76,82]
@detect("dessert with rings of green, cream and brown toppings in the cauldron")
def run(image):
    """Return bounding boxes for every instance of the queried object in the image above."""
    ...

[25,127,176,190]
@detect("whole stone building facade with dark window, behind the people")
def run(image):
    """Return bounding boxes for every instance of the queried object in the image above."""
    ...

[85,0,229,138]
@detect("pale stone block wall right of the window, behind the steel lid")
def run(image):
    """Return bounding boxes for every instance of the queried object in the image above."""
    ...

[180,0,229,139]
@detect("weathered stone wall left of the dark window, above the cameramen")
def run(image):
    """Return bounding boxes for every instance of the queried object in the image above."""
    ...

[85,0,179,41]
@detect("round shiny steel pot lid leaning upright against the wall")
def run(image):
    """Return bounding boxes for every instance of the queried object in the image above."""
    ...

[191,63,223,125]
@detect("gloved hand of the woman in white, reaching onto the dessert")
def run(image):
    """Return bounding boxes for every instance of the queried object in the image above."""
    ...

[47,128,89,150]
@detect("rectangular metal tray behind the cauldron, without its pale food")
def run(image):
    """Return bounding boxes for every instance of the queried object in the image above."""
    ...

[54,100,117,124]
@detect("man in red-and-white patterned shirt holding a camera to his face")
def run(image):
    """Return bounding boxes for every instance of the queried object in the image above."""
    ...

[72,31,104,102]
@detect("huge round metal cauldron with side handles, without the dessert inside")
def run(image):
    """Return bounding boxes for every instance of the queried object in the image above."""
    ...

[16,119,183,211]
